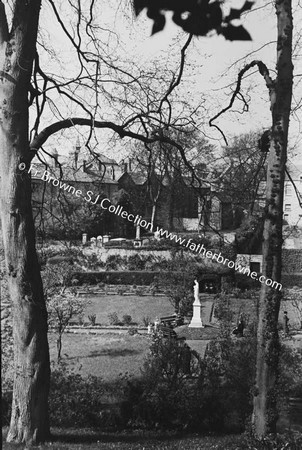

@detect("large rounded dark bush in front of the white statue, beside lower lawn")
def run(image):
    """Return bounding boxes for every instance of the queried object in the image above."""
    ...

[127,335,202,429]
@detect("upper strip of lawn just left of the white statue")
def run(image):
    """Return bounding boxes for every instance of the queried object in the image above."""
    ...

[83,295,174,325]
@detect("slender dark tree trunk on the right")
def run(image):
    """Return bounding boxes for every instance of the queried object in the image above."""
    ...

[253,0,293,437]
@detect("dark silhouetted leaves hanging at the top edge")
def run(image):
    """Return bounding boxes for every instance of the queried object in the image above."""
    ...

[133,0,254,41]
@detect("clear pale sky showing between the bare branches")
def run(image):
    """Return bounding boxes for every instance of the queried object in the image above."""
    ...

[33,0,302,165]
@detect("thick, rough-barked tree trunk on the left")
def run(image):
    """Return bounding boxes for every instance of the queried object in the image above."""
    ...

[0,0,50,443]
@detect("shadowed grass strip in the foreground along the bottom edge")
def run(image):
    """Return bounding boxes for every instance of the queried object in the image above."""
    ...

[3,429,252,450]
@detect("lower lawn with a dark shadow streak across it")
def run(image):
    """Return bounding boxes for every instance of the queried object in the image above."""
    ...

[49,333,150,381]
